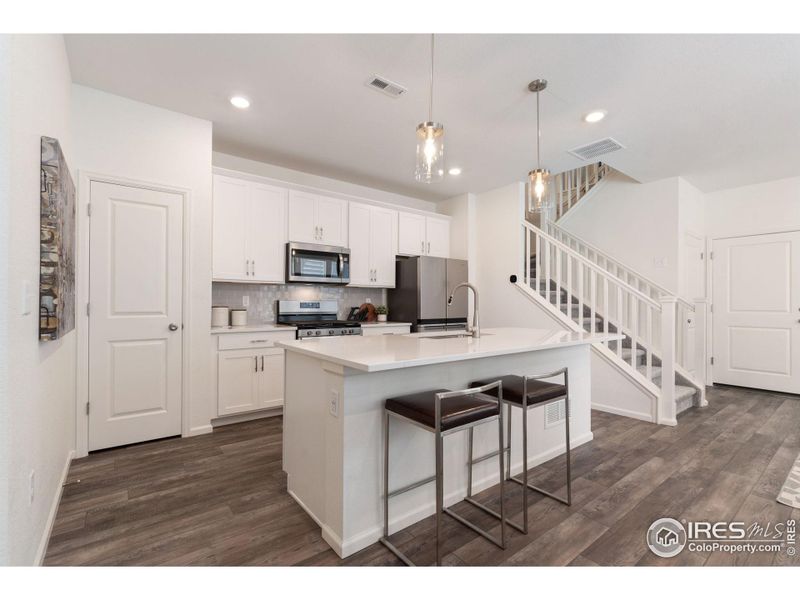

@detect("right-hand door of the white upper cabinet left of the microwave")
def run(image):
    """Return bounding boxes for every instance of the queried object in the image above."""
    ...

[248,183,288,283]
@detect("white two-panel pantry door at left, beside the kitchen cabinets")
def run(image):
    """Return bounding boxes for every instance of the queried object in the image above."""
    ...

[89,182,183,450]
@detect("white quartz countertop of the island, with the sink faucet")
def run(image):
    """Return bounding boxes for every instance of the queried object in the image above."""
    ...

[275,327,622,372]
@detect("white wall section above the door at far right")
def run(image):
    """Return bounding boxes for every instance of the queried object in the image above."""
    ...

[705,177,800,238]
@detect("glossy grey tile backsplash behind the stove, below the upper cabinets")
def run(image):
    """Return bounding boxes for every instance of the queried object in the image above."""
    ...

[209,282,386,323]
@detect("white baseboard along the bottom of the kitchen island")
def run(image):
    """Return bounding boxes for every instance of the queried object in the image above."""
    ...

[287,431,594,558]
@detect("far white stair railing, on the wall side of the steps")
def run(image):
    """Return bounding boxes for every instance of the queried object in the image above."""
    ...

[544,221,704,380]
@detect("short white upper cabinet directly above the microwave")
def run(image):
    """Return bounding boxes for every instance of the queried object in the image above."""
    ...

[289,190,347,246]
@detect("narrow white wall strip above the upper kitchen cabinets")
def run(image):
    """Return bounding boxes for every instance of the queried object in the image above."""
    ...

[212,152,436,212]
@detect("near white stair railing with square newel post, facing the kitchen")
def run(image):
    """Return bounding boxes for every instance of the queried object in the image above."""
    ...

[522,221,686,424]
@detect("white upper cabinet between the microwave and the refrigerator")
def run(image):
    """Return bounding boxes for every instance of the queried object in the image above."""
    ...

[349,202,397,288]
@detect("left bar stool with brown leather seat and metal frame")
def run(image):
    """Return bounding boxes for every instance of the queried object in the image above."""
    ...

[380,381,506,566]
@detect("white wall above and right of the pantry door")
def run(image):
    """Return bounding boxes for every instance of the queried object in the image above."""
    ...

[72,85,216,440]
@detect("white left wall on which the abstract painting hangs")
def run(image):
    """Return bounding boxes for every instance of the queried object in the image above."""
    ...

[0,35,76,565]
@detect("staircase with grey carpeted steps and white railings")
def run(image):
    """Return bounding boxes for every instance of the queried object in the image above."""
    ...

[517,164,705,425]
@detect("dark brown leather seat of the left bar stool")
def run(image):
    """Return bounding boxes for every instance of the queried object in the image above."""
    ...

[386,390,500,431]
